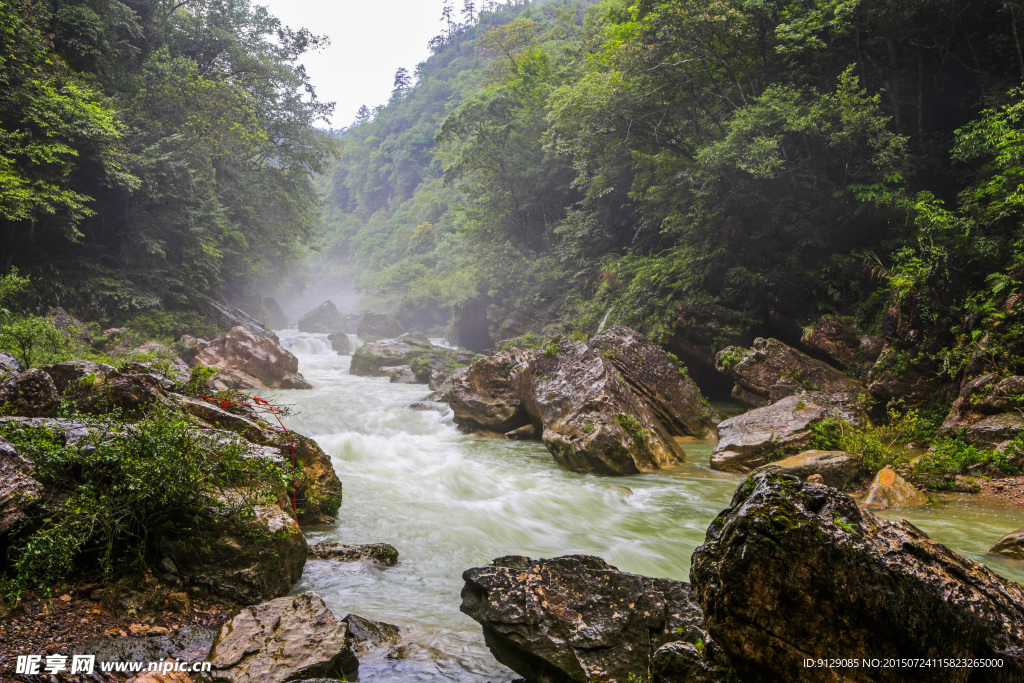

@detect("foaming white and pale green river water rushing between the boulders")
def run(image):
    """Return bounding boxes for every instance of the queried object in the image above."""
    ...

[278,331,1024,683]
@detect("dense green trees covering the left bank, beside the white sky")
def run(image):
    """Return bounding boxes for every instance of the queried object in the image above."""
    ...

[0,0,334,319]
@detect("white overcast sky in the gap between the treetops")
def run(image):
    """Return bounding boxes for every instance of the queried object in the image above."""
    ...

[253,0,442,128]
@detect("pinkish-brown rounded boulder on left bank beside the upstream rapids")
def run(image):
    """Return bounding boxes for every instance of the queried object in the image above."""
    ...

[189,326,312,389]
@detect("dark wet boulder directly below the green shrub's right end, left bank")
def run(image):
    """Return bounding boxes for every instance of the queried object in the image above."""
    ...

[161,494,306,605]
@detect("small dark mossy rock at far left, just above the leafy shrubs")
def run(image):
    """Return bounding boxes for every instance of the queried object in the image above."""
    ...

[42,360,170,414]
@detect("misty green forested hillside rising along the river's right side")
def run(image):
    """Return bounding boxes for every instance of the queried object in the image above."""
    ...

[314,0,1024,401]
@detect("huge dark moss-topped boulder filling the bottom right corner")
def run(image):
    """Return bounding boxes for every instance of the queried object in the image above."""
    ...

[690,473,1024,683]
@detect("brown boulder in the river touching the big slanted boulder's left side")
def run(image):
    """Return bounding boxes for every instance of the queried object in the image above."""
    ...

[447,349,535,432]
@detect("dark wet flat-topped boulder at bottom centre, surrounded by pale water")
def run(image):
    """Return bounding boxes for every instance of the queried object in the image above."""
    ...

[462,555,724,683]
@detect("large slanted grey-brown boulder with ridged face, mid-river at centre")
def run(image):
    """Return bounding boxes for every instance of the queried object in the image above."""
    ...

[510,338,684,474]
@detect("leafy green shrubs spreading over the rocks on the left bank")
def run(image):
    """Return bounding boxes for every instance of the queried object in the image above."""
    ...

[0,410,291,591]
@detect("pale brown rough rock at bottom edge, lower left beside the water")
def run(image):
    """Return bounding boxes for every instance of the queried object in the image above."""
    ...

[209,592,359,683]
